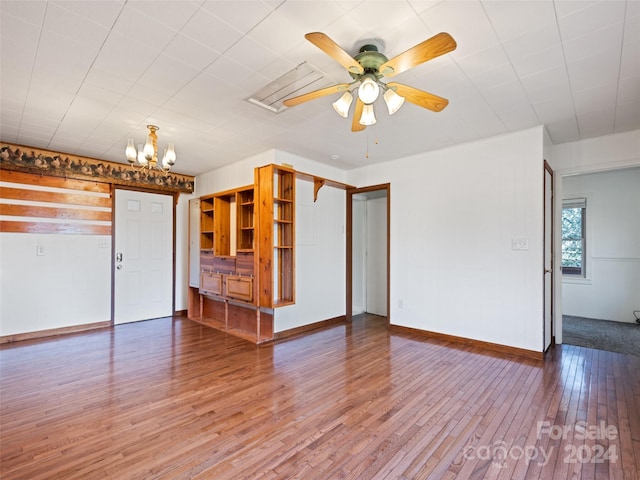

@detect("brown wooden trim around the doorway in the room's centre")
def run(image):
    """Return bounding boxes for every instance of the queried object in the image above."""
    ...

[345,183,391,327]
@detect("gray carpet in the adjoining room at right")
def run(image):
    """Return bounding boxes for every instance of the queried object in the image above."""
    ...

[562,315,640,356]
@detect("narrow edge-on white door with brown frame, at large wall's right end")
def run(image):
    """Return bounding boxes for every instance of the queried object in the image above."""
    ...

[543,162,553,351]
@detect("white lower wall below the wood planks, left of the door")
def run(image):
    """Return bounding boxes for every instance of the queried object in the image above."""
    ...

[0,232,111,336]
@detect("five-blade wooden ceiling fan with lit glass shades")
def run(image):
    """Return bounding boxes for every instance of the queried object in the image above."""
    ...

[283,32,456,132]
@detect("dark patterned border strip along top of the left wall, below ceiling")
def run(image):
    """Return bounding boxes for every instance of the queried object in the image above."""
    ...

[0,142,194,193]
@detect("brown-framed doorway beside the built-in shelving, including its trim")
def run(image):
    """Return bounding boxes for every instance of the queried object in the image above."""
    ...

[346,184,390,325]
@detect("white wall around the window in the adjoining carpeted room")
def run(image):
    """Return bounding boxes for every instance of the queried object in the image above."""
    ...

[562,167,640,323]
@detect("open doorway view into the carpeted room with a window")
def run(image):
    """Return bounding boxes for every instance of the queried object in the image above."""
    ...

[556,166,640,351]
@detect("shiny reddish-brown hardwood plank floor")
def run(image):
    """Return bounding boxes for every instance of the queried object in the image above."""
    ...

[0,316,640,480]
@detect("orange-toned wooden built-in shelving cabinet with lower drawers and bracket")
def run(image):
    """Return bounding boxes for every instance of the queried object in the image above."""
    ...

[188,165,348,343]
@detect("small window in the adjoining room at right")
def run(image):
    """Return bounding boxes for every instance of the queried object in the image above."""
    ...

[562,198,587,277]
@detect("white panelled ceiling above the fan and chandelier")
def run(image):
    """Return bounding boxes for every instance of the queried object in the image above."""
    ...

[0,0,640,175]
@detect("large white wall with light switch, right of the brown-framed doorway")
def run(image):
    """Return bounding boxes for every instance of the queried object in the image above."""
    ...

[347,127,543,351]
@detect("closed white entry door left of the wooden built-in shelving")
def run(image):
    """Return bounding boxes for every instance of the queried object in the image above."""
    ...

[114,190,173,324]
